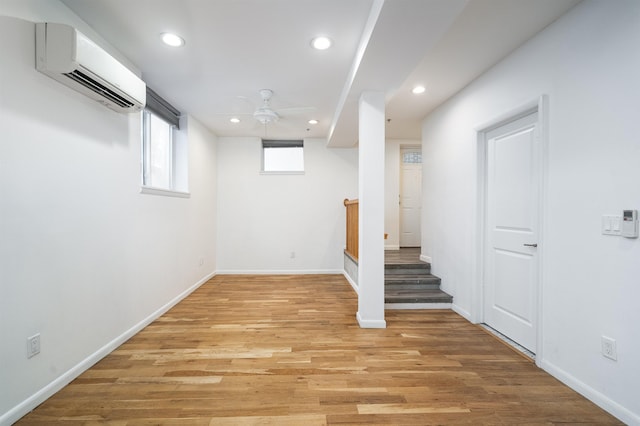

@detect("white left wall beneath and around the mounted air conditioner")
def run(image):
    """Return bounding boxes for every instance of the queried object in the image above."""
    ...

[0,0,216,424]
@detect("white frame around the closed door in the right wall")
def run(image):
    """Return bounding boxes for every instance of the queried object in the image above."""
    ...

[470,95,549,367]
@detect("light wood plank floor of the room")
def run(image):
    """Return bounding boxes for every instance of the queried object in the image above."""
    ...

[18,275,620,426]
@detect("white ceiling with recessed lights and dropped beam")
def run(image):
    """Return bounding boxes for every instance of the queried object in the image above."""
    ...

[62,0,579,146]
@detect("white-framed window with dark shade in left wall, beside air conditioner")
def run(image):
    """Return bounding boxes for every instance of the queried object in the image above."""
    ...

[142,89,188,195]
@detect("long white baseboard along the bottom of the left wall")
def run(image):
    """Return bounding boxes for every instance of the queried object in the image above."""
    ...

[0,272,216,426]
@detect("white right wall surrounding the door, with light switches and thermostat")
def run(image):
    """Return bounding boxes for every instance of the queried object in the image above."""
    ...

[423,0,640,424]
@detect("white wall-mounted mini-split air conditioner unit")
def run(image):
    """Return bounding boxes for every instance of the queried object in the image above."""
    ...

[36,22,146,113]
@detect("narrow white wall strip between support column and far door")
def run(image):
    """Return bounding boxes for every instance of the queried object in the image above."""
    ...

[384,139,421,250]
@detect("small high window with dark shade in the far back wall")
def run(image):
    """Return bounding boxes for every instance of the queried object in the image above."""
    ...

[262,139,304,174]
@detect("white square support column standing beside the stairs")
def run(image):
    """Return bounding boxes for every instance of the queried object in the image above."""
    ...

[357,92,387,328]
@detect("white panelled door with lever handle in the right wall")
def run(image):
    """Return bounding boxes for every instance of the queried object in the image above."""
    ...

[484,113,539,353]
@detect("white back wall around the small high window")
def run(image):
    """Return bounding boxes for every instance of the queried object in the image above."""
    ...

[217,138,358,273]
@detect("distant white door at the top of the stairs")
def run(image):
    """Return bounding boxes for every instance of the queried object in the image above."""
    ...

[400,148,422,247]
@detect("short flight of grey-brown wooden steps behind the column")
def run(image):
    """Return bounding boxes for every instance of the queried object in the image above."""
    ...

[384,248,453,309]
